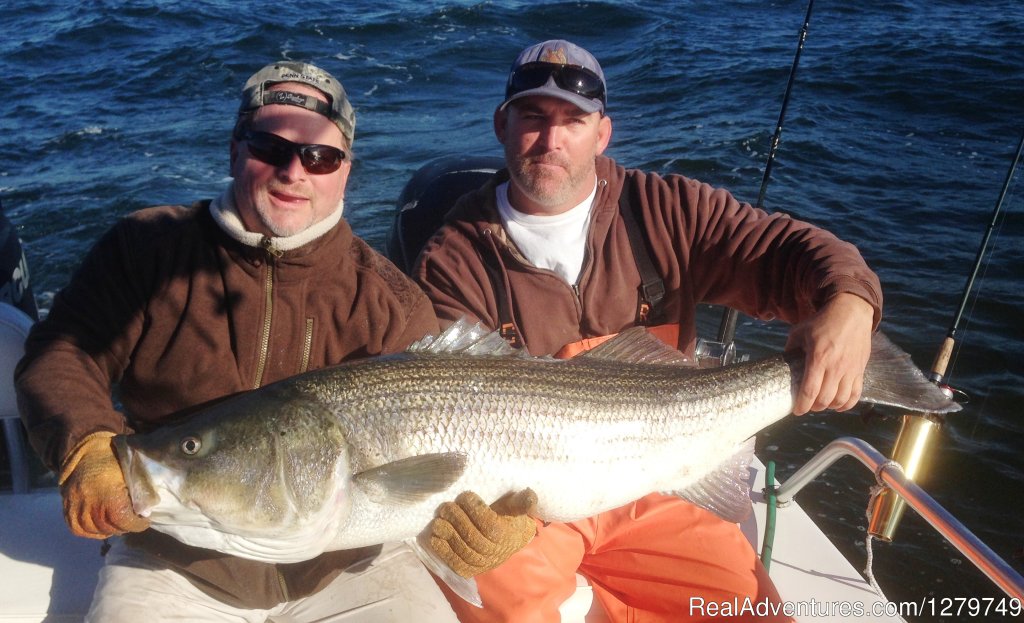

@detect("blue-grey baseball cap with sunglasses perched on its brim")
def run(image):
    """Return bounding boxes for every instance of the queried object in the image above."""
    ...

[500,39,607,114]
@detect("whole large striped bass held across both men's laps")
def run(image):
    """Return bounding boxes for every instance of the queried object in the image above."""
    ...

[115,323,958,602]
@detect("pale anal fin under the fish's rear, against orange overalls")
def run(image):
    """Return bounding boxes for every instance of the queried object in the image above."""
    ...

[673,438,754,524]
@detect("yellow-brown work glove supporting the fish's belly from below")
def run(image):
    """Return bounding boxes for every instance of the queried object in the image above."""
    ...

[429,489,537,578]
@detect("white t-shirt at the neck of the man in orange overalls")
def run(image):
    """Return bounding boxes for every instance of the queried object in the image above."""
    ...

[495,177,597,285]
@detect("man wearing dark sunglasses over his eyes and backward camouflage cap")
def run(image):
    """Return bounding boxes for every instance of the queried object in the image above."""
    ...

[15,63,464,623]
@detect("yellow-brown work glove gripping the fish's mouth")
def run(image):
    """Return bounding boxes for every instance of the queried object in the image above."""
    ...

[57,431,150,539]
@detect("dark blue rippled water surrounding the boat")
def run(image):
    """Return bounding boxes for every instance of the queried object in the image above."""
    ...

[0,0,1024,620]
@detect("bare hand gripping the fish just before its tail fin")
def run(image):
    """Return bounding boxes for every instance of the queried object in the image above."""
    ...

[785,293,874,415]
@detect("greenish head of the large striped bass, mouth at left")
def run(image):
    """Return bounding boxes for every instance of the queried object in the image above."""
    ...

[114,386,350,546]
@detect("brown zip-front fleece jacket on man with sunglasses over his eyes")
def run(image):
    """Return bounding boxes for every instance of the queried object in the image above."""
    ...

[15,202,437,608]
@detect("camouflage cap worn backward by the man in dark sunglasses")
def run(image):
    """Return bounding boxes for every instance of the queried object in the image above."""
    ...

[239,60,355,147]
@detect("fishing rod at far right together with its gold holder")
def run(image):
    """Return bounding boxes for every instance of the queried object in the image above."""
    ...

[867,127,1024,542]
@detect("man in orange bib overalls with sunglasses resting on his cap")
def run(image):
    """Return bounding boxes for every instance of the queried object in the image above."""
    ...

[414,40,882,622]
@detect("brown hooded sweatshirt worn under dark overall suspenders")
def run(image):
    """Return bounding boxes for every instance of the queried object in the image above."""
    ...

[413,157,882,355]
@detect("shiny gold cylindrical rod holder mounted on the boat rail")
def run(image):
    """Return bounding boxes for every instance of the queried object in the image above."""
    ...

[867,414,940,542]
